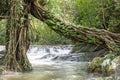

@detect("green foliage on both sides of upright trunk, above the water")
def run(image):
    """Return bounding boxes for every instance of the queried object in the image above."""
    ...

[0,19,72,45]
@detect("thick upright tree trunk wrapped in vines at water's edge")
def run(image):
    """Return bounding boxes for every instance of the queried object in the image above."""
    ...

[5,0,32,71]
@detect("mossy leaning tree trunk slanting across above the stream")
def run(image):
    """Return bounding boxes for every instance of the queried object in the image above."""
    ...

[26,0,120,53]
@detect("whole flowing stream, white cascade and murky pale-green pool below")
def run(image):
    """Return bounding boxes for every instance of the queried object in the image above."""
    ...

[0,45,110,80]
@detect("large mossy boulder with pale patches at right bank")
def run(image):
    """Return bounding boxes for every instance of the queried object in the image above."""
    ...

[88,54,120,76]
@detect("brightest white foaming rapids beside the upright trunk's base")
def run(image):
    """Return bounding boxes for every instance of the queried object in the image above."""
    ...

[27,46,72,66]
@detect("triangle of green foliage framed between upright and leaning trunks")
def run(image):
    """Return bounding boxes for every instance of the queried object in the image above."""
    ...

[31,19,71,45]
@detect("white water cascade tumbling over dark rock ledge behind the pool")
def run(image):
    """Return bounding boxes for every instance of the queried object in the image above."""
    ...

[27,45,84,65]
